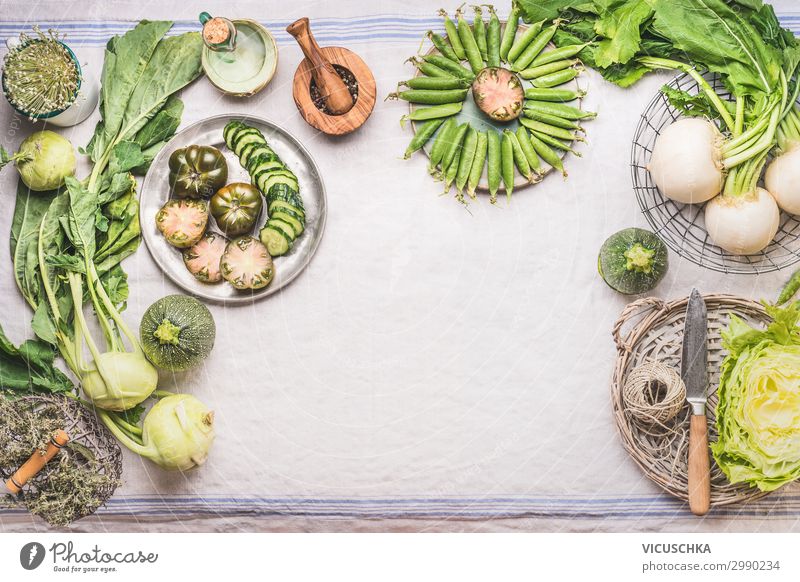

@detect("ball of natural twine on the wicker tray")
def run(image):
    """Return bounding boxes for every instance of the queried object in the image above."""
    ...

[622,361,686,426]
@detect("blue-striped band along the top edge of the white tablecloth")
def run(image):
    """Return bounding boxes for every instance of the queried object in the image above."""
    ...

[0,13,800,46]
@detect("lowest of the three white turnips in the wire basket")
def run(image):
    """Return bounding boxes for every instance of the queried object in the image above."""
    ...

[705,188,780,255]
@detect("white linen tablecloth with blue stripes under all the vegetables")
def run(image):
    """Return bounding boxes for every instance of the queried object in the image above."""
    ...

[0,0,800,531]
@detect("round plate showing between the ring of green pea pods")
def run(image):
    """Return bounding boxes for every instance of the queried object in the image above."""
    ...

[408,20,583,193]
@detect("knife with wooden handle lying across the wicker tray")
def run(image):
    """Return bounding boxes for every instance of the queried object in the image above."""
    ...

[681,289,711,515]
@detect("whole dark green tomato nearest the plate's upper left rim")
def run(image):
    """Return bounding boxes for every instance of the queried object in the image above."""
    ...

[169,145,228,198]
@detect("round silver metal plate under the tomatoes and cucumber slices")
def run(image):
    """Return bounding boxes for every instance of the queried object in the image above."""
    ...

[139,114,328,304]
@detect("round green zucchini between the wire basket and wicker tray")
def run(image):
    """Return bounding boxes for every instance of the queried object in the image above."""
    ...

[597,228,668,295]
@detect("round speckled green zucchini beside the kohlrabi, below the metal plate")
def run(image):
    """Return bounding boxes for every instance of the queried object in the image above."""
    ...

[139,295,217,372]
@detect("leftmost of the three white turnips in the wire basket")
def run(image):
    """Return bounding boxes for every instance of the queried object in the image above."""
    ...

[647,118,724,204]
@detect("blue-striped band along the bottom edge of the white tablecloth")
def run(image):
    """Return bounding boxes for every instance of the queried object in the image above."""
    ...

[6,495,800,520]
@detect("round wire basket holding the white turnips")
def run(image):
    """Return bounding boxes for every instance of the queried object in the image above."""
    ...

[631,73,800,275]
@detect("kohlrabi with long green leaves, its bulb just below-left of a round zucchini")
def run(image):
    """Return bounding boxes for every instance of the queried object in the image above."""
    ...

[0,21,202,464]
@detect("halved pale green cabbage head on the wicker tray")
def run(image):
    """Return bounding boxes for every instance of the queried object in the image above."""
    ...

[711,304,800,491]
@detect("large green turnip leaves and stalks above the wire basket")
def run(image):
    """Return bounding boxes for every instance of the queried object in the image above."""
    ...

[519,0,800,197]
